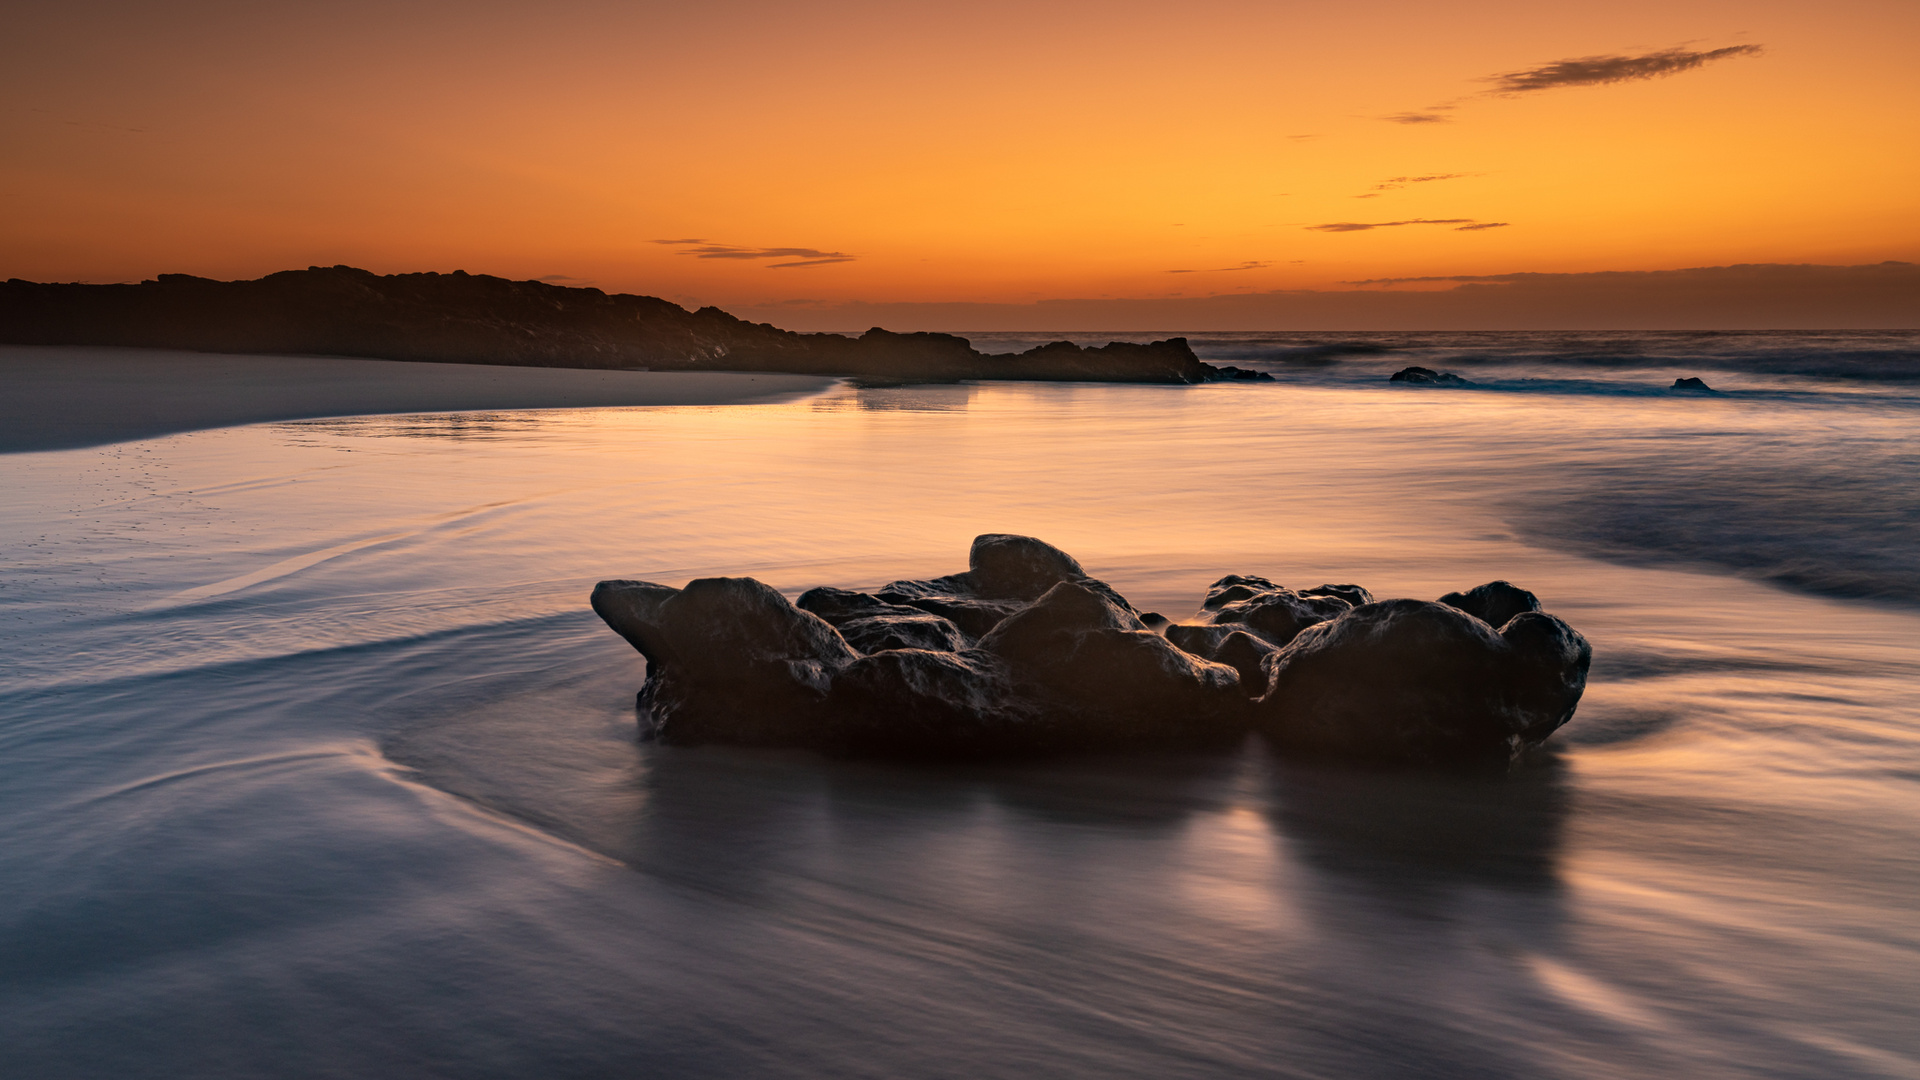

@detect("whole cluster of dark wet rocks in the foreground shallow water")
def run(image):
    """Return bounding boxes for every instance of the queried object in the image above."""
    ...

[593,534,1592,767]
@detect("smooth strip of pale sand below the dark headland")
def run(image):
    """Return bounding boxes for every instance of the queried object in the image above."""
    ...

[0,346,835,454]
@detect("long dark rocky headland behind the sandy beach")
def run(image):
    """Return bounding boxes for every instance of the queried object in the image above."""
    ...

[0,267,1260,382]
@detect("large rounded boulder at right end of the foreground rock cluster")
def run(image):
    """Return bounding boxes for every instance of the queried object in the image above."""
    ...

[1254,600,1592,767]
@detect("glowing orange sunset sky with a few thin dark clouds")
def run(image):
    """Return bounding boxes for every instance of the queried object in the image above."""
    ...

[0,0,1920,329]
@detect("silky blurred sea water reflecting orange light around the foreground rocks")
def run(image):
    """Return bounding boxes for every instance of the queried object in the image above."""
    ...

[0,334,1920,1078]
